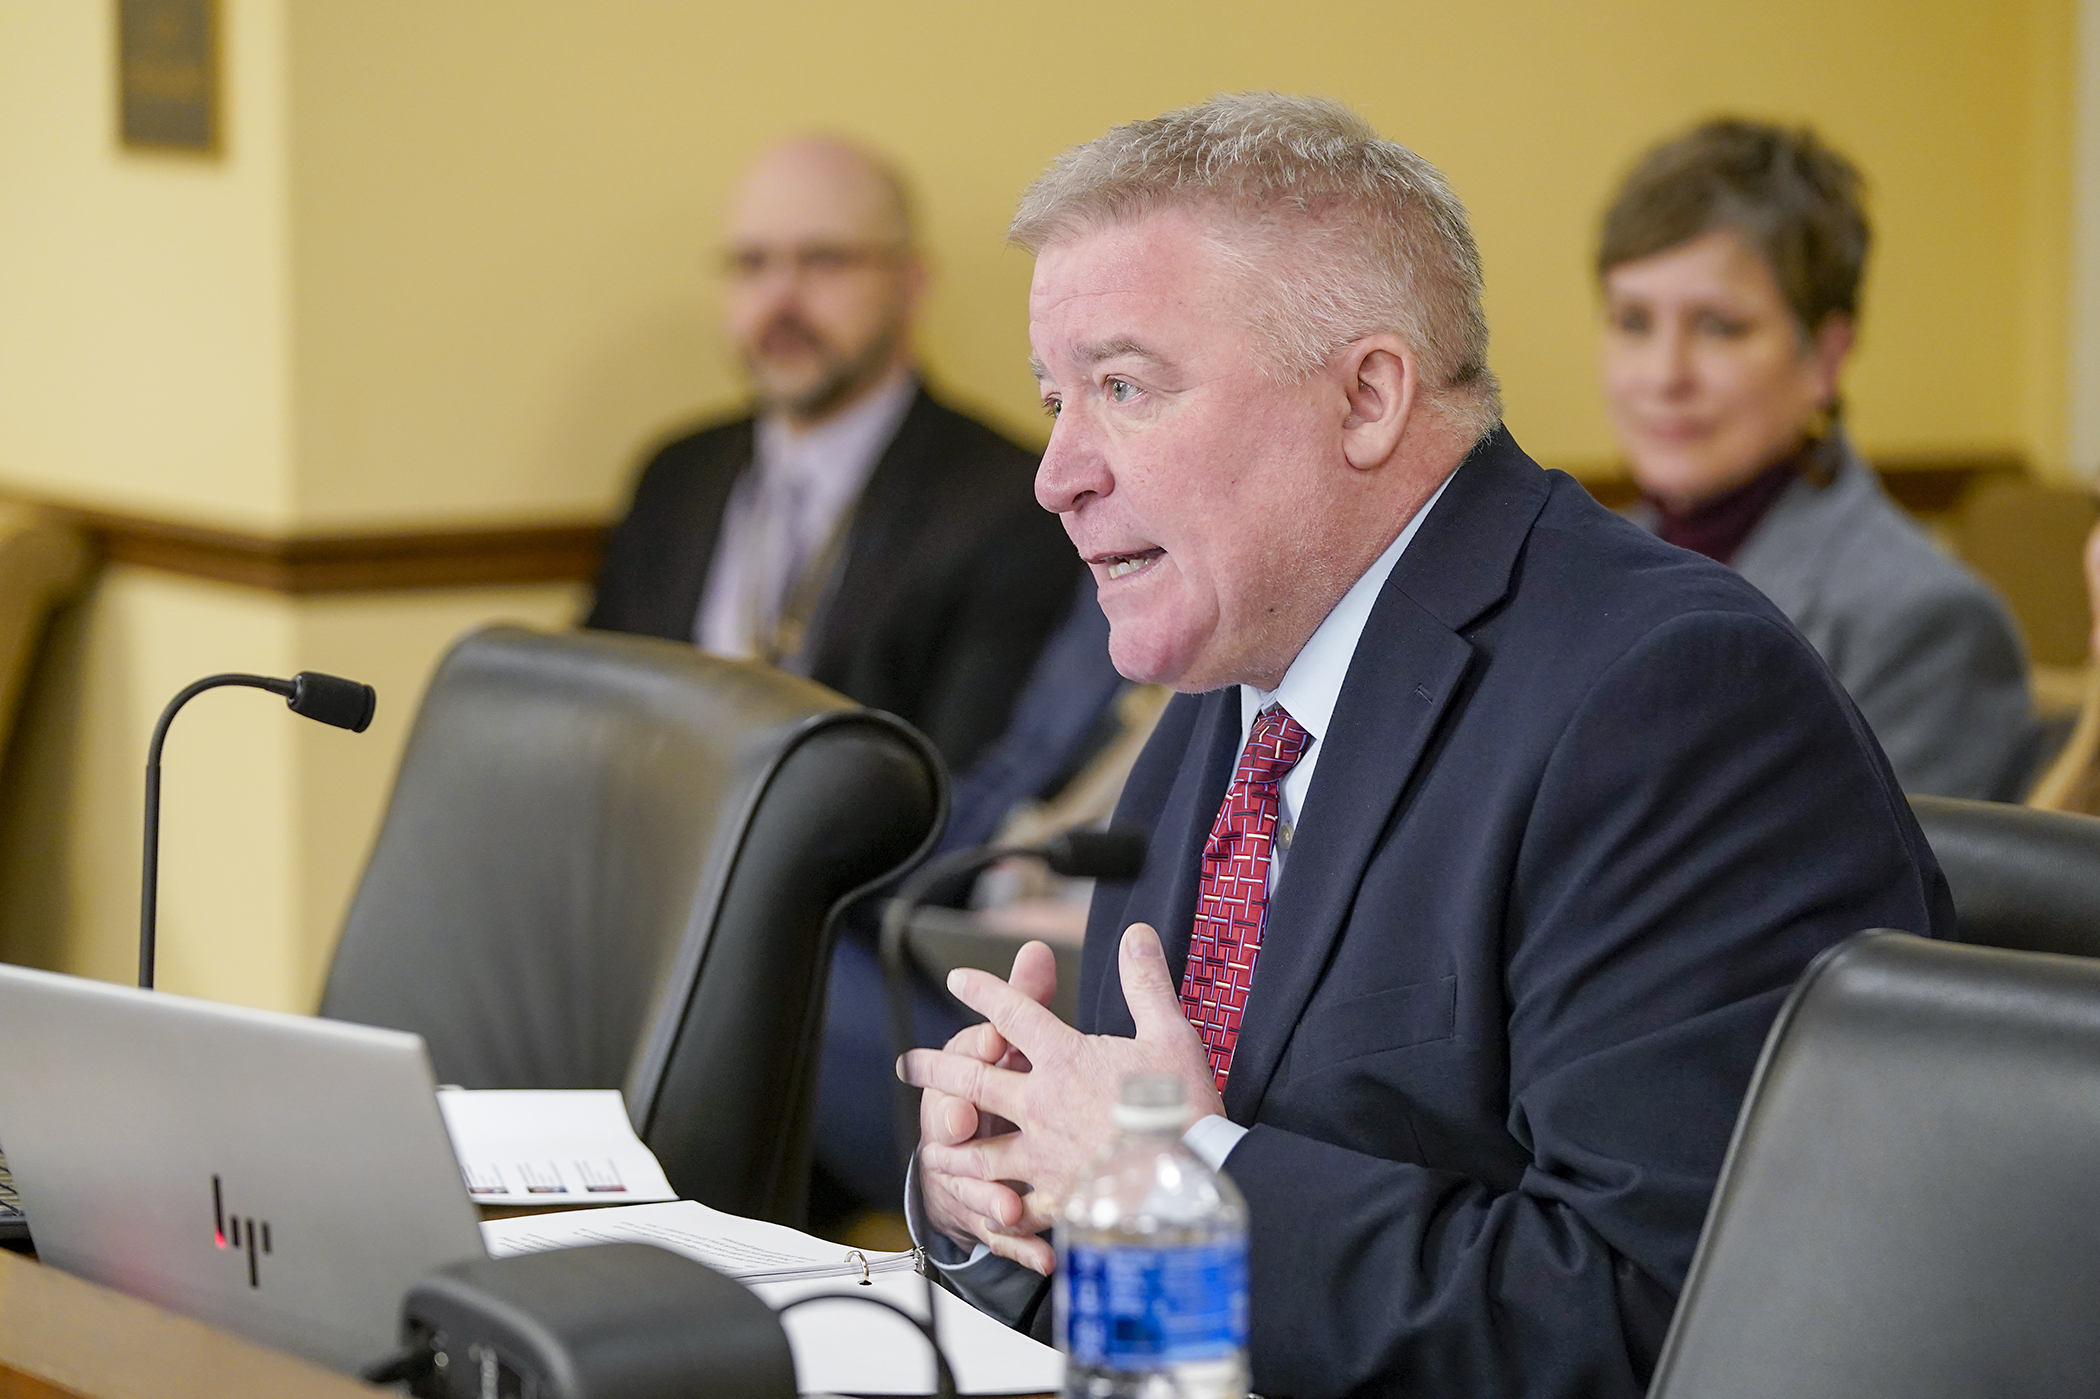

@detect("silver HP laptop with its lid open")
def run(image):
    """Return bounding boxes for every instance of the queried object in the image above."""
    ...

[0,964,483,1372]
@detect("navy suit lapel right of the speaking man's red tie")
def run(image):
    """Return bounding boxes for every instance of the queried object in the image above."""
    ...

[1226,429,1550,1122]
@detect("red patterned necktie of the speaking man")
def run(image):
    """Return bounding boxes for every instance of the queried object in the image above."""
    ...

[1182,706,1313,1092]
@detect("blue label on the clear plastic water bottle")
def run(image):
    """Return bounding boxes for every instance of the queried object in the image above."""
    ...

[1058,1239,1247,1370]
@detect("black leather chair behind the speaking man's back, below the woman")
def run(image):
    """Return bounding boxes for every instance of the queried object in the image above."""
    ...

[1911,796,2100,958]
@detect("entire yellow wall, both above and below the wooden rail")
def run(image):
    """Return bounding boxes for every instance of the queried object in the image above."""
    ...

[0,0,2090,1006]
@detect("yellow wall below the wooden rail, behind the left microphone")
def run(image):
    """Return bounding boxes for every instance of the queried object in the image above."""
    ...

[0,567,578,1008]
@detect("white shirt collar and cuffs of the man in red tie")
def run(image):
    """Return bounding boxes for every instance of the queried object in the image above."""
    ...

[905,473,1457,1277]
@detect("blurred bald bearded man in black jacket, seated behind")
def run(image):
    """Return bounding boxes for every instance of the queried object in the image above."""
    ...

[586,137,1077,769]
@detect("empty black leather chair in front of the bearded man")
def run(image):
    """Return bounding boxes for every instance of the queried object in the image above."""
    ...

[321,628,947,1223]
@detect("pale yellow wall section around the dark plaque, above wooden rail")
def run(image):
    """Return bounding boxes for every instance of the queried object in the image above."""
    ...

[0,0,294,529]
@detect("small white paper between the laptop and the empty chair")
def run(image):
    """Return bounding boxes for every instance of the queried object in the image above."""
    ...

[437,1088,678,1206]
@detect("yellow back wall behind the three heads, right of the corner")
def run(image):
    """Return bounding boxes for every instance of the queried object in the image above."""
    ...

[266,0,2073,533]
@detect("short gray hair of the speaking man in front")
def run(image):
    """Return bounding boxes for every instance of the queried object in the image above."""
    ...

[1008,92,1502,437]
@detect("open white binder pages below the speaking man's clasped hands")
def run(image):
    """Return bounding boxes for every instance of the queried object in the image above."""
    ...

[481,1199,1065,1395]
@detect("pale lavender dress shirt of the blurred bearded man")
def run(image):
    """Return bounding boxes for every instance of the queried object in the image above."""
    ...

[693,370,918,660]
